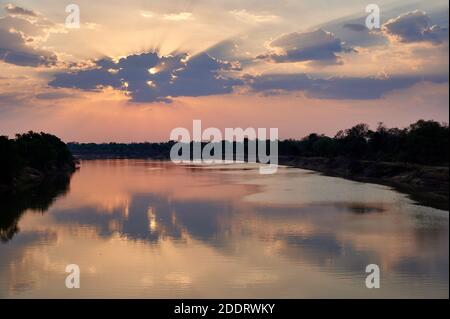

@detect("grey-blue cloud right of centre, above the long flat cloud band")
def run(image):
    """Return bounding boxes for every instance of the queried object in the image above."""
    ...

[257,29,348,64]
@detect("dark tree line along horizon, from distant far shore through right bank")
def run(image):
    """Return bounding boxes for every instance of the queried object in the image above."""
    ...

[68,120,449,165]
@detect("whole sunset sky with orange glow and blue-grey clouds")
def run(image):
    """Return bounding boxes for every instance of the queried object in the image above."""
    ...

[0,0,449,142]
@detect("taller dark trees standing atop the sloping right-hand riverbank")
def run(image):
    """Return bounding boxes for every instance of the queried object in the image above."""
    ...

[280,120,449,165]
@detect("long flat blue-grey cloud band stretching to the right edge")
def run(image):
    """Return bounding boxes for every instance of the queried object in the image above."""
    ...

[246,74,448,100]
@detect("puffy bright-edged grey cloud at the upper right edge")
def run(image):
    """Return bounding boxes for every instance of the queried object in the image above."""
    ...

[382,10,448,44]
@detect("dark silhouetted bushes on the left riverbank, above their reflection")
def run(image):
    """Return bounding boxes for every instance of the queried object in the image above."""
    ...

[0,132,75,191]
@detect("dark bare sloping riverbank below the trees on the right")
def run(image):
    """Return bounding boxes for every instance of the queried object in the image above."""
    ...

[279,156,449,211]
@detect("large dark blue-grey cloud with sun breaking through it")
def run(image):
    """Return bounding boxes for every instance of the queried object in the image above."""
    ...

[49,53,242,102]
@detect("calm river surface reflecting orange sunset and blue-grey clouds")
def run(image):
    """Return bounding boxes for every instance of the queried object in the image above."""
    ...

[0,160,449,298]
